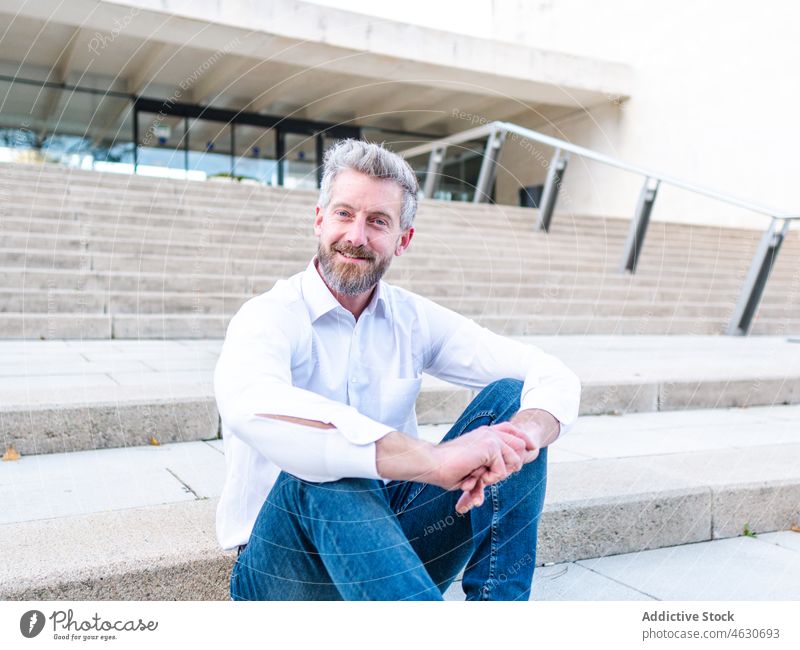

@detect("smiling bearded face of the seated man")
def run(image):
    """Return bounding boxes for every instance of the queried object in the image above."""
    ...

[314,169,414,296]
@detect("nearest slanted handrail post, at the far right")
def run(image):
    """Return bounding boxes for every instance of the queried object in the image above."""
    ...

[725,217,791,336]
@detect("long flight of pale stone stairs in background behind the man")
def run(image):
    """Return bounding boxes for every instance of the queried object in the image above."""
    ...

[0,164,800,339]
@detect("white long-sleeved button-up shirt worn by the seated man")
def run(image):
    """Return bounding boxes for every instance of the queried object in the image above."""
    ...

[214,260,580,549]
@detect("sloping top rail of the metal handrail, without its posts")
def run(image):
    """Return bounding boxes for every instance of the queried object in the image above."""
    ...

[399,121,800,219]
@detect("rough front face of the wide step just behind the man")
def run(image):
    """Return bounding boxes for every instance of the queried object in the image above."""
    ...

[7,371,800,455]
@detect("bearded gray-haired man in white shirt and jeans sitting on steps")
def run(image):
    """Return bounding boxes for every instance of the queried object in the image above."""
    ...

[214,140,580,600]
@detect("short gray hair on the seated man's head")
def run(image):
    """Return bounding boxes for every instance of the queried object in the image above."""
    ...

[319,139,419,230]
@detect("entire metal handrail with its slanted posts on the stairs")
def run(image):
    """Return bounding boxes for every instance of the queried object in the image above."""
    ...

[400,121,800,335]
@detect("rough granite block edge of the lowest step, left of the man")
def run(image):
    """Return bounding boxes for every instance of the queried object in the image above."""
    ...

[0,499,235,600]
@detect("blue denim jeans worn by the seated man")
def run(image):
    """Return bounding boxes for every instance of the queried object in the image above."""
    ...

[231,379,547,600]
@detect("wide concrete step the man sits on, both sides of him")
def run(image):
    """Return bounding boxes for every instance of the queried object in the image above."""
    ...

[0,406,800,600]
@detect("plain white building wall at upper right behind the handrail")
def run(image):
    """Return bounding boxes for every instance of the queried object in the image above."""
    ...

[494,0,800,228]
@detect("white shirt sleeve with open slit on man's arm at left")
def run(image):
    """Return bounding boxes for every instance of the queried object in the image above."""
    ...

[214,298,393,482]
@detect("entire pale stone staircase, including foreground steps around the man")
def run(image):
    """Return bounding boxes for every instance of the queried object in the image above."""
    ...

[0,165,800,600]
